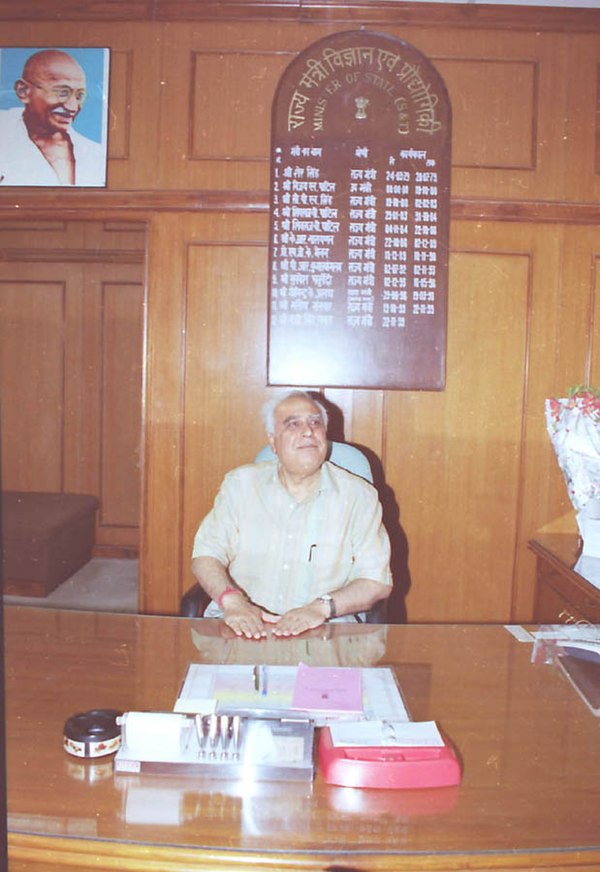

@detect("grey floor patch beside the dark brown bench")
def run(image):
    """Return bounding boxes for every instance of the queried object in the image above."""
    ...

[4,557,138,613]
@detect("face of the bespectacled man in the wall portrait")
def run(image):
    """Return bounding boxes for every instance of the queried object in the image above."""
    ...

[17,58,85,133]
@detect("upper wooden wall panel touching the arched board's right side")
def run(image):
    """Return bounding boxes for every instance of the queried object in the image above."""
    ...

[414,30,567,201]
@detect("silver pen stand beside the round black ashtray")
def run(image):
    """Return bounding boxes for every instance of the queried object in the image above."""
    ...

[115,712,314,781]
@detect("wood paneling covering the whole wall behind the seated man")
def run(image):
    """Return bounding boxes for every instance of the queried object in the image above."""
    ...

[0,6,600,621]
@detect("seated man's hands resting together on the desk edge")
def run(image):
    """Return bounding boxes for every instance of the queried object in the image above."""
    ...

[223,596,326,639]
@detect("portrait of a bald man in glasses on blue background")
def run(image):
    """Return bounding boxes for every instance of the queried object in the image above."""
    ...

[0,47,110,188]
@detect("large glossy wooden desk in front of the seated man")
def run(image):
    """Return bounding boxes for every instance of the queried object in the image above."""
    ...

[5,607,600,872]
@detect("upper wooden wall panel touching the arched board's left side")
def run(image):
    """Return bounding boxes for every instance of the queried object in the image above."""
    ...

[160,22,303,190]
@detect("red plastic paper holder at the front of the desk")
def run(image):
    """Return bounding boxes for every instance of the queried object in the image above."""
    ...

[319,727,461,788]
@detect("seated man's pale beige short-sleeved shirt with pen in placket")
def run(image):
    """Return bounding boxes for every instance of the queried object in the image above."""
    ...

[193,461,392,616]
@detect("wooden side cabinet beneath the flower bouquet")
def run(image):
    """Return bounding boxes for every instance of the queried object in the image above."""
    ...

[529,533,600,624]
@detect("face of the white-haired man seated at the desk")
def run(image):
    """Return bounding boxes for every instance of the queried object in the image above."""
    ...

[269,397,327,476]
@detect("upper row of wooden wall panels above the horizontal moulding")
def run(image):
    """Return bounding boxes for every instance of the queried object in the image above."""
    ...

[3,16,600,201]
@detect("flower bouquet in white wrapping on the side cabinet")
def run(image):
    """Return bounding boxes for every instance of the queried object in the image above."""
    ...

[546,386,600,557]
